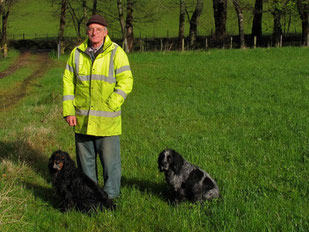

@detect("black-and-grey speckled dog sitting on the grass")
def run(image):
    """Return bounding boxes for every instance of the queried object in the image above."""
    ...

[158,150,219,203]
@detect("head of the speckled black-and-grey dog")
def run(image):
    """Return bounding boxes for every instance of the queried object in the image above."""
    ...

[158,149,184,174]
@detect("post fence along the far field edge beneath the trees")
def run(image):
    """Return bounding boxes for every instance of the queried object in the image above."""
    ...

[8,33,309,52]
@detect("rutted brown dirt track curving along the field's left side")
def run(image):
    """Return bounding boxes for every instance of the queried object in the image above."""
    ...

[0,51,53,111]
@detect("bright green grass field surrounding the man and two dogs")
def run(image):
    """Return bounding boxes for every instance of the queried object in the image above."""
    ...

[0,48,309,232]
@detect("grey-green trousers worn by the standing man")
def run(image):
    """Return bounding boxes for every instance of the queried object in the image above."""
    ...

[75,133,121,199]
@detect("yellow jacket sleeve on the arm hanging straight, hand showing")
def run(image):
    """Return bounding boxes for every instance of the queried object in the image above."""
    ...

[62,49,75,117]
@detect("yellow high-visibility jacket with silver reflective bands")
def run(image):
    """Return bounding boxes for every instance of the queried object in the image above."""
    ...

[63,36,133,136]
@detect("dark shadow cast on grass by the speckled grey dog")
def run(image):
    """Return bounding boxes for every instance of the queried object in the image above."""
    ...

[121,176,174,204]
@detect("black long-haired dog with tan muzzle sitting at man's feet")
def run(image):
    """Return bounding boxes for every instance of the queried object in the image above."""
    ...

[48,150,115,213]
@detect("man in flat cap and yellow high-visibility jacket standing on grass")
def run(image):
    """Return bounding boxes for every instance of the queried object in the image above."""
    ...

[63,15,133,199]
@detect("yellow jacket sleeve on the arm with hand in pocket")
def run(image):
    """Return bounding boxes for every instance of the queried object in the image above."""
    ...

[107,47,133,111]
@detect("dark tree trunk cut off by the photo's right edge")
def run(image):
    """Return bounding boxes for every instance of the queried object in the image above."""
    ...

[297,0,309,47]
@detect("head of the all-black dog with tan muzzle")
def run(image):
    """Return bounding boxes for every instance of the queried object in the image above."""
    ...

[48,150,75,174]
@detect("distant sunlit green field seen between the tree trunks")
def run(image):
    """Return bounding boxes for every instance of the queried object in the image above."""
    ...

[5,0,301,39]
